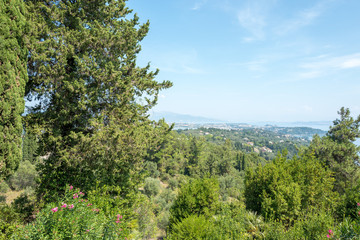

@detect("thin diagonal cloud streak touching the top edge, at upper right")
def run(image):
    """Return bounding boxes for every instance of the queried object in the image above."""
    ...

[276,0,334,35]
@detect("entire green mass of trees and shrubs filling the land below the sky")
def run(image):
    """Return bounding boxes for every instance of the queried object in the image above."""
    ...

[0,0,360,240]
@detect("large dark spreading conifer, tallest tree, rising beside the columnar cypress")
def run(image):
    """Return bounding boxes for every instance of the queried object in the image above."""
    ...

[27,0,171,201]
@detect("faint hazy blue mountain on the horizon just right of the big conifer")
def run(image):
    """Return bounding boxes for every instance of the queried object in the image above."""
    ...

[150,112,225,123]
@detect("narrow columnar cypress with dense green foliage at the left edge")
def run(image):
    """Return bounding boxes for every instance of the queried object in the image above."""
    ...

[0,0,28,181]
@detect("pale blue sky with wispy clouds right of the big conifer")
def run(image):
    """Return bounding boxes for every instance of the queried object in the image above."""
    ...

[127,0,360,122]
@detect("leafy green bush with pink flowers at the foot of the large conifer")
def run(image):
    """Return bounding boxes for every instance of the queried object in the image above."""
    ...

[12,189,128,239]
